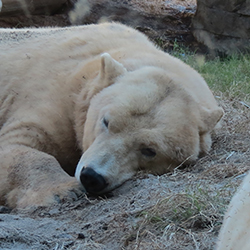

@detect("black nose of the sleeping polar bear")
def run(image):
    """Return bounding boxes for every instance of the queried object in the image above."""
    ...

[80,168,108,194]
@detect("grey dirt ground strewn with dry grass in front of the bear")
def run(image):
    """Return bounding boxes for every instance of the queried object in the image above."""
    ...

[0,1,250,250]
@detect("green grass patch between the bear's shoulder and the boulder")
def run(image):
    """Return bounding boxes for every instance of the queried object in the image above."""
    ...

[171,45,250,102]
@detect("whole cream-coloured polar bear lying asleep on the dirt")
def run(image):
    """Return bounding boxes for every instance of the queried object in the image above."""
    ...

[0,23,223,207]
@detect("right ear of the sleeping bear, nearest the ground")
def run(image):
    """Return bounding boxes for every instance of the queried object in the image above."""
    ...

[199,107,224,133]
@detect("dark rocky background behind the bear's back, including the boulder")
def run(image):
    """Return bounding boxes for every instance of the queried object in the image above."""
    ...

[0,0,250,55]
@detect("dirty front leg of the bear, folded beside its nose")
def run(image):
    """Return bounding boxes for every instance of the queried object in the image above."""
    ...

[0,145,81,208]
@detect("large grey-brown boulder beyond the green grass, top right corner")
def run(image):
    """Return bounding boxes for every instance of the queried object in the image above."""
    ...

[193,0,250,54]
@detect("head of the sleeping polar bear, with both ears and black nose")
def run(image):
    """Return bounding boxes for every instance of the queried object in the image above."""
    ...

[75,54,222,194]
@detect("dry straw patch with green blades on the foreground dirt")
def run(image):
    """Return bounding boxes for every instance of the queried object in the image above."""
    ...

[126,181,231,249]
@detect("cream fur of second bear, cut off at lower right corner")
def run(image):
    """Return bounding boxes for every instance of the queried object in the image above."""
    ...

[216,173,250,250]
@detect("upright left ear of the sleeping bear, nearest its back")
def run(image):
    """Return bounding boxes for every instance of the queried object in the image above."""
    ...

[100,53,127,85]
